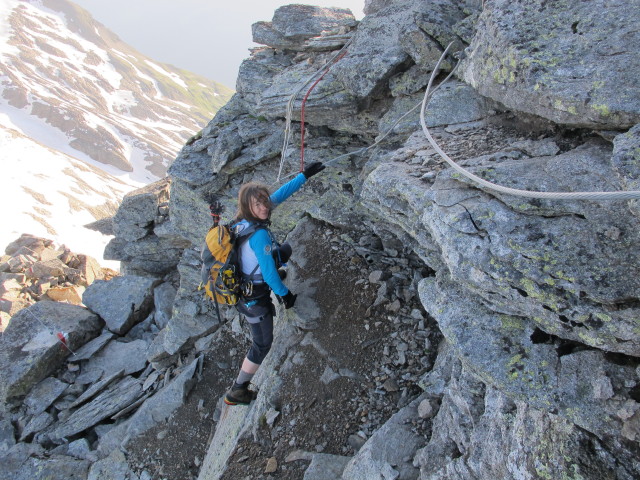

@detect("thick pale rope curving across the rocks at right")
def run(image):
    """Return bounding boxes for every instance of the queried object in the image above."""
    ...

[420,43,640,200]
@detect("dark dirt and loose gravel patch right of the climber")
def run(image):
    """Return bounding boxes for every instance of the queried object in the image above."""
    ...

[222,219,440,480]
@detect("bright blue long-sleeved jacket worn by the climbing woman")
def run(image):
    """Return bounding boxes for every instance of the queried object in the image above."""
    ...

[236,173,307,297]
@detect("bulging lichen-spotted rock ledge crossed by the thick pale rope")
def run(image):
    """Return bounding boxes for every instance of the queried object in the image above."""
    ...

[363,141,640,356]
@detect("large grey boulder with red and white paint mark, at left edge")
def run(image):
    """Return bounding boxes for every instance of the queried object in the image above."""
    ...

[0,302,102,402]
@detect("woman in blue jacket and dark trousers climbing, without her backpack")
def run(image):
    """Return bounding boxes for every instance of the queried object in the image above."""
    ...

[224,162,325,405]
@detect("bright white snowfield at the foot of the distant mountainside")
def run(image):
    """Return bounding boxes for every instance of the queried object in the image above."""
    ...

[0,120,135,270]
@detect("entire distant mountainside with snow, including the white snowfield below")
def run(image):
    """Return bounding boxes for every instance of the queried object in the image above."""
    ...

[0,0,232,259]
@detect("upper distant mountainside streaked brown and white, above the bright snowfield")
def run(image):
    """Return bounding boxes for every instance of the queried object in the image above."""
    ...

[0,0,231,182]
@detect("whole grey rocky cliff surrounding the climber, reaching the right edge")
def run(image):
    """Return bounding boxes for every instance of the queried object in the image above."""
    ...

[0,0,640,480]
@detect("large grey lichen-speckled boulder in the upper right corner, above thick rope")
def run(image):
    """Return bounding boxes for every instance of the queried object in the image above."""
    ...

[463,0,640,130]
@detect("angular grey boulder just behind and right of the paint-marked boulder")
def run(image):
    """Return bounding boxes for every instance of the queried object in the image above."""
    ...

[82,275,158,335]
